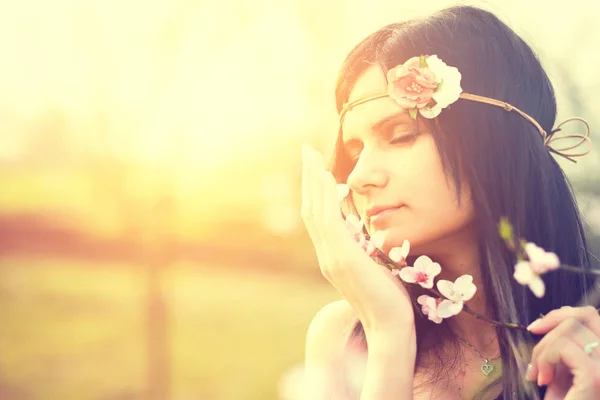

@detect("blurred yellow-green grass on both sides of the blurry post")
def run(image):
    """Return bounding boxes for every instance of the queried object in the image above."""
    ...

[0,259,337,400]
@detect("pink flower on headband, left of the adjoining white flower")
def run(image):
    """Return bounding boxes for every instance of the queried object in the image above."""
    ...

[387,57,438,109]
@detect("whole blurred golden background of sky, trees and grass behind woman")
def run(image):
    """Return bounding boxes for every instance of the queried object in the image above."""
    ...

[0,0,600,400]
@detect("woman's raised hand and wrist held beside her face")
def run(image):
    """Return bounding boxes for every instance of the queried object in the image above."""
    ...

[302,146,414,337]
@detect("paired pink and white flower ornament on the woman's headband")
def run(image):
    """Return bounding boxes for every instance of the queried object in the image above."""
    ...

[387,55,462,119]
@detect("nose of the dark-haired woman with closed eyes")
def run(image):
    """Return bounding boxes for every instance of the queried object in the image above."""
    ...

[346,149,389,195]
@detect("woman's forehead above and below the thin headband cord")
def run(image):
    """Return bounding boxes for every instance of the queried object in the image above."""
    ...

[342,65,408,141]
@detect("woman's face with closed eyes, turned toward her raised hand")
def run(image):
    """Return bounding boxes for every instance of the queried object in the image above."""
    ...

[342,66,474,254]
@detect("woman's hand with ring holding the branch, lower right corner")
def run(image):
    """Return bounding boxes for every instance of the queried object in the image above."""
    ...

[527,307,600,400]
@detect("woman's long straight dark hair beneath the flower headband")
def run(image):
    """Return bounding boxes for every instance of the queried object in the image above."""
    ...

[332,6,594,399]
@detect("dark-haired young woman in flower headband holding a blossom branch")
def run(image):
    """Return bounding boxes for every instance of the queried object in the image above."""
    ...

[302,6,600,400]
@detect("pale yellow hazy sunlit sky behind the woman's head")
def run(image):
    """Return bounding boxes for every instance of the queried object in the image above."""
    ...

[0,0,600,230]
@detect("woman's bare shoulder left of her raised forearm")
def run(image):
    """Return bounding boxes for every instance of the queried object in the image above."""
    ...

[306,300,358,365]
